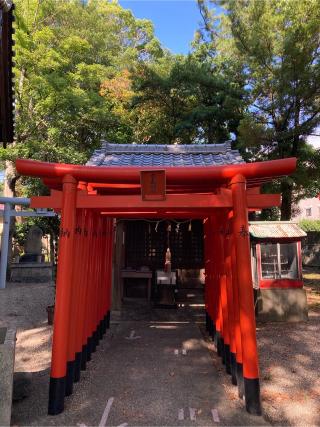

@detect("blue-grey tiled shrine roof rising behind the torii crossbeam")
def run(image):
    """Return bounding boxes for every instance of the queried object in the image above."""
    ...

[87,141,244,167]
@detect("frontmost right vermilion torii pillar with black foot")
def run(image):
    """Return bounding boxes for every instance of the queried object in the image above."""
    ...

[230,175,261,415]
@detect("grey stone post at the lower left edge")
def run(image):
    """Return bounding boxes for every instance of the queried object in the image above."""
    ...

[0,328,16,426]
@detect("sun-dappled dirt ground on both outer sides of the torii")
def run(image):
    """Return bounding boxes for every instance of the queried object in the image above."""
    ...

[0,269,320,426]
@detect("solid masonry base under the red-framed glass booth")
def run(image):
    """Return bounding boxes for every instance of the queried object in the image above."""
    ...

[256,288,308,322]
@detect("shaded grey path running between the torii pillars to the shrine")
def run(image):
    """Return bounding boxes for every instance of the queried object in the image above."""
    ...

[12,320,269,427]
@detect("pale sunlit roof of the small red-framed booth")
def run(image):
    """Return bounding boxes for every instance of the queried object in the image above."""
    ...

[249,221,307,239]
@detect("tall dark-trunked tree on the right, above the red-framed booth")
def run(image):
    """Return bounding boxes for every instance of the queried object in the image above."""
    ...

[197,0,320,219]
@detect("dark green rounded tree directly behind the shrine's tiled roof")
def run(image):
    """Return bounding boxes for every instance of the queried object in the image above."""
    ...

[133,54,243,144]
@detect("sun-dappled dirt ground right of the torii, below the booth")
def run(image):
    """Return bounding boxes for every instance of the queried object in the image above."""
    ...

[212,268,320,426]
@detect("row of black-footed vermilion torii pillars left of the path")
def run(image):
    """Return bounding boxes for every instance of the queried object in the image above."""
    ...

[48,183,113,415]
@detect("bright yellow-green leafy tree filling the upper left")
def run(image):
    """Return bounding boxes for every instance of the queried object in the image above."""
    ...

[0,0,162,196]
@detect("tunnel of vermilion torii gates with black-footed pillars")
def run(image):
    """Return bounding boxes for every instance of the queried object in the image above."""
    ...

[16,158,296,415]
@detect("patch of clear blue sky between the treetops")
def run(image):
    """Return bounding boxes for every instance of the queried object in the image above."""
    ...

[119,0,201,53]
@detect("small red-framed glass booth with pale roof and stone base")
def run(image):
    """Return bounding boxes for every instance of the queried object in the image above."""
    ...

[249,221,308,321]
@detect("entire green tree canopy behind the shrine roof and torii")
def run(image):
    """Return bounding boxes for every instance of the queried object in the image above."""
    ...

[0,0,320,219]
